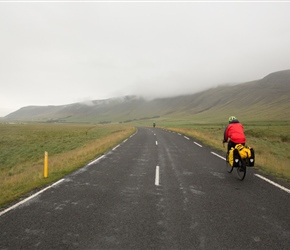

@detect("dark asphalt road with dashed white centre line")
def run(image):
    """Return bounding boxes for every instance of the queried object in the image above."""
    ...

[0,128,290,250]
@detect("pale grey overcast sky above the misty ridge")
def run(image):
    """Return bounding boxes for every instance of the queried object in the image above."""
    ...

[0,1,290,116]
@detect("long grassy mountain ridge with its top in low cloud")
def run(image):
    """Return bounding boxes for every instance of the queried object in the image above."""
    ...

[4,70,290,123]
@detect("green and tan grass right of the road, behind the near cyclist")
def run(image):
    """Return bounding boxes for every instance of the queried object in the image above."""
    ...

[164,122,290,183]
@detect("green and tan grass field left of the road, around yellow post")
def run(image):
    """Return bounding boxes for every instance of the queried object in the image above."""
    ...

[0,124,135,207]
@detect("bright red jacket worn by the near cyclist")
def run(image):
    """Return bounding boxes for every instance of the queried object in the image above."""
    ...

[224,121,246,143]
